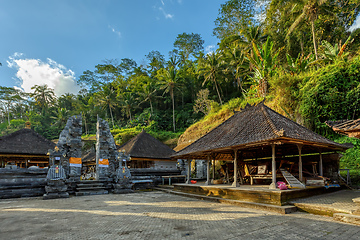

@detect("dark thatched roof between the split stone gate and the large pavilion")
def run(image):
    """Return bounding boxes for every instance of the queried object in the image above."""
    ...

[119,130,175,160]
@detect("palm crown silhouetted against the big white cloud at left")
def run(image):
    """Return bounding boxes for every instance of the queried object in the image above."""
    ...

[31,84,56,115]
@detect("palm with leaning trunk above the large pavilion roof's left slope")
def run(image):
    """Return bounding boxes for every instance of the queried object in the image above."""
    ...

[198,52,225,105]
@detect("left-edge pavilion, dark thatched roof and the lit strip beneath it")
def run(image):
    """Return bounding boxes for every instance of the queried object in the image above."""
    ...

[0,128,55,167]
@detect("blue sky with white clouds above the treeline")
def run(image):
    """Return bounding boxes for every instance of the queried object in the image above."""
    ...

[0,0,226,95]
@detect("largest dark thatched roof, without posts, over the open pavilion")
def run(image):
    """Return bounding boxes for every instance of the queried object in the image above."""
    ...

[172,102,349,159]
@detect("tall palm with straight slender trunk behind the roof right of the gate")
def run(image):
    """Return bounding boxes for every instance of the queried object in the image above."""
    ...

[159,66,180,132]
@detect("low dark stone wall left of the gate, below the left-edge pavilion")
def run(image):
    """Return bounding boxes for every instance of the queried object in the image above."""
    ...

[0,168,48,199]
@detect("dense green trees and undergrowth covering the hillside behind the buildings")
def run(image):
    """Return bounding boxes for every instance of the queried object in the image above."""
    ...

[0,0,360,172]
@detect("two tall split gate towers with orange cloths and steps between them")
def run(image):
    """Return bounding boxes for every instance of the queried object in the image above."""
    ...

[49,115,118,181]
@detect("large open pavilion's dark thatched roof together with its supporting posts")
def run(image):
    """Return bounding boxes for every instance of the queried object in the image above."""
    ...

[172,102,349,187]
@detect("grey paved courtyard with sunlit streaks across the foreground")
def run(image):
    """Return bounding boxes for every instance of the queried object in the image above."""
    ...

[0,191,360,240]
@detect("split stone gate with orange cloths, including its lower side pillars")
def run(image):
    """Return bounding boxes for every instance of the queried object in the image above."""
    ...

[44,115,131,199]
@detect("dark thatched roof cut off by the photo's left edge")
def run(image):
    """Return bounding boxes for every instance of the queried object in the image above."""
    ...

[0,128,55,155]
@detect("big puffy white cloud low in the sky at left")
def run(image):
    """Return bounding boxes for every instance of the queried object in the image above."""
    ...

[7,53,80,96]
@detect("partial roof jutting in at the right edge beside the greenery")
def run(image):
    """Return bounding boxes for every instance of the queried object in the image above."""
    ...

[325,119,360,138]
